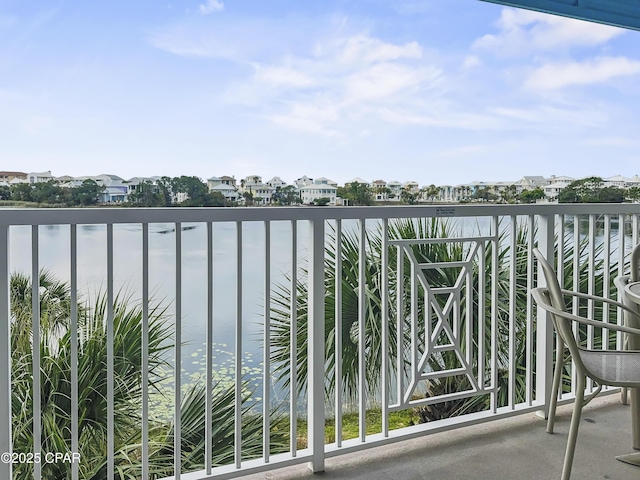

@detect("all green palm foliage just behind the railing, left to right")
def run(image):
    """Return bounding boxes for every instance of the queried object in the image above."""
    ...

[10,219,617,480]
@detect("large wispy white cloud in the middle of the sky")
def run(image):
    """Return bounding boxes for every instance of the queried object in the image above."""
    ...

[228,33,442,138]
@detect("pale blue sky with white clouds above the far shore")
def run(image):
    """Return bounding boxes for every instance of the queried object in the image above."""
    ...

[0,0,640,185]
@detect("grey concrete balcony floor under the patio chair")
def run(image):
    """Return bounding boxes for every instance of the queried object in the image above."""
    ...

[243,394,640,480]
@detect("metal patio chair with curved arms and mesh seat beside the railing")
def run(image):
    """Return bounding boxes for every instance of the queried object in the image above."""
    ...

[531,249,640,480]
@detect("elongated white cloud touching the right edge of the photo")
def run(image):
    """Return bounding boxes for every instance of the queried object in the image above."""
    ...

[524,57,640,90]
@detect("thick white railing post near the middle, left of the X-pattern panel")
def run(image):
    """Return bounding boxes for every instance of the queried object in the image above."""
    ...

[306,218,325,473]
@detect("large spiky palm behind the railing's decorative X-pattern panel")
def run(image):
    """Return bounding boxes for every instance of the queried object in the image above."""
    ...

[271,219,617,421]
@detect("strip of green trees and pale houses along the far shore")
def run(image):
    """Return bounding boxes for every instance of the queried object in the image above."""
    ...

[0,176,640,208]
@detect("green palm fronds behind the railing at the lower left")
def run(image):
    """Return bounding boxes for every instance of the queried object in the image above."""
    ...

[10,272,287,480]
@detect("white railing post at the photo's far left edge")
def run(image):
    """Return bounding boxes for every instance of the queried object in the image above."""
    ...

[0,225,12,478]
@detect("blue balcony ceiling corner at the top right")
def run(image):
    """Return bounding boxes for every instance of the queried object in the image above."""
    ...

[483,0,640,30]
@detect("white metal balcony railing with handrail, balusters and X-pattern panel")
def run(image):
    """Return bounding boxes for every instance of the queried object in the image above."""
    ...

[0,204,640,480]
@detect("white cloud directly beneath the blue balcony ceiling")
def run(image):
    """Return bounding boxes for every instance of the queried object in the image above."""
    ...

[473,8,625,56]
